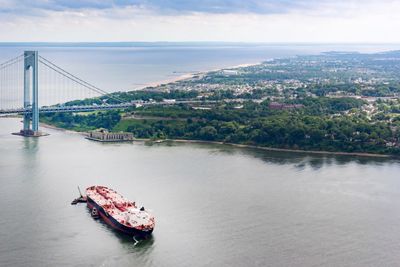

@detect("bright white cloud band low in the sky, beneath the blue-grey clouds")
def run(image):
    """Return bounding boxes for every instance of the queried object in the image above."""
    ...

[0,0,400,42]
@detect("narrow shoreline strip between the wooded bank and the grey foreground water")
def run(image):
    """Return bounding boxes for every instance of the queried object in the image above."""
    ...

[41,123,396,159]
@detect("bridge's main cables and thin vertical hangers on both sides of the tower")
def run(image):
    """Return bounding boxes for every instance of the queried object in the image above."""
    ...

[0,50,132,115]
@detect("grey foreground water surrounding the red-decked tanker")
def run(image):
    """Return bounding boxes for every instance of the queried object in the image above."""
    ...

[0,118,400,266]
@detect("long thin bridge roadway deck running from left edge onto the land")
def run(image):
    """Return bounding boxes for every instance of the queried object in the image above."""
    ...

[0,100,222,115]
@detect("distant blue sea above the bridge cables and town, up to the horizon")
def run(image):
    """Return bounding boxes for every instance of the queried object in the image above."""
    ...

[0,43,400,92]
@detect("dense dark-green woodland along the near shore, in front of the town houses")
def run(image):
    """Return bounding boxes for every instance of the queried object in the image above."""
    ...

[42,97,400,155]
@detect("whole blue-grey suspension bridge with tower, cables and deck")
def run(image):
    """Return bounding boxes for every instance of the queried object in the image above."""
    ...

[0,51,135,136]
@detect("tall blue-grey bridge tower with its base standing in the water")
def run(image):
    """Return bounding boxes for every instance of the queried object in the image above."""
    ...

[15,51,48,137]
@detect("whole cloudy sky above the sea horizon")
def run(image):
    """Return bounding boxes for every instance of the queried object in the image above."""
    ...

[0,0,400,43]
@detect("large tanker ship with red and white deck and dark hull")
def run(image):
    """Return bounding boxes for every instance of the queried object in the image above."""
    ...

[86,186,155,236]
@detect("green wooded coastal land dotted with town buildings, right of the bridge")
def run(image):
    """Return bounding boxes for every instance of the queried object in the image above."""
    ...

[44,51,400,154]
